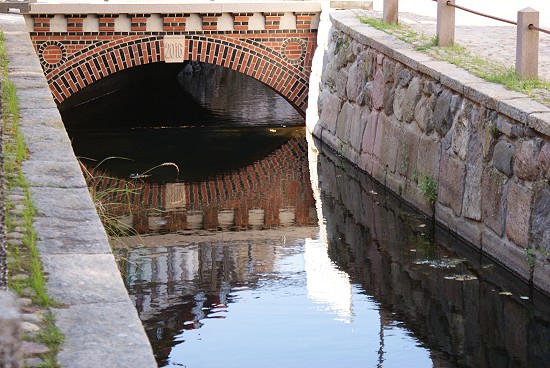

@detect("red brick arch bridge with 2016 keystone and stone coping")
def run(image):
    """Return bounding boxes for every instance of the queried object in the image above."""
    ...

[25,1,320,113]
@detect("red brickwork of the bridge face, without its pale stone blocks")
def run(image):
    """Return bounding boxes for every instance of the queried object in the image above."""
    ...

[30,14,317,112]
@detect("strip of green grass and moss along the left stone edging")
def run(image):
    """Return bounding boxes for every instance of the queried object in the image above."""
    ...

[0,33,63,368]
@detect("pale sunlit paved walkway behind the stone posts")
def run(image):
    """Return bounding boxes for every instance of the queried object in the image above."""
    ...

[373,0,550,80]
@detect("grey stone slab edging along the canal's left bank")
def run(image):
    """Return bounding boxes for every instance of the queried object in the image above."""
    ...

[0,15,156,367]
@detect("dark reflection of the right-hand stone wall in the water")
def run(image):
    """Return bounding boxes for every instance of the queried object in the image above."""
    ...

[319,140,550,367]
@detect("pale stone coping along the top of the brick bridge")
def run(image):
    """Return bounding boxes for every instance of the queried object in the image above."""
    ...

[29,0,321,14]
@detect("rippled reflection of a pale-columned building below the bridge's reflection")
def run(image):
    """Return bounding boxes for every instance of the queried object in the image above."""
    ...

[126,241,280,359]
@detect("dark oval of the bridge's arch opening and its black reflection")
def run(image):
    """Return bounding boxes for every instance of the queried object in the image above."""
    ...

[59,63,304,182]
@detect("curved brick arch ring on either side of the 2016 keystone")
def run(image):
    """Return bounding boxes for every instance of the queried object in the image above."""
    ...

[45,34,309,112]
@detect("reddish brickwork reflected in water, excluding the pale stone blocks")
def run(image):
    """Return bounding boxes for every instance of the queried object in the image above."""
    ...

[88,138,314,232]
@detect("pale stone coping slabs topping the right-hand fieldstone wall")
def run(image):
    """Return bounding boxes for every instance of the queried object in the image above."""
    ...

[330,10,550,136]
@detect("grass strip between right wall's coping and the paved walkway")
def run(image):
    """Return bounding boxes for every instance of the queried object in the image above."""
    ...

[359,15,550,105]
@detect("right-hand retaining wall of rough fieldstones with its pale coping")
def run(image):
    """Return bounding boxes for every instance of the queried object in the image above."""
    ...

[313,11,550,292]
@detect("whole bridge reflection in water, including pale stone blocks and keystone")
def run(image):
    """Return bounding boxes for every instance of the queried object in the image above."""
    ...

[89,138,317,233]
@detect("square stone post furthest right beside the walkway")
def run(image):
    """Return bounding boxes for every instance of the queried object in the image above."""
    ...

[516,8,539,78]
